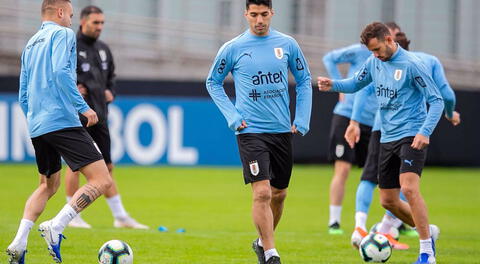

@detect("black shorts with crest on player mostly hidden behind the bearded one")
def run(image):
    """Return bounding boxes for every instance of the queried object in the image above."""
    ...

[328,114,372,168]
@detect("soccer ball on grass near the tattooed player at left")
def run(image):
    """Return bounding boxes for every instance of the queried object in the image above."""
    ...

[98,240,133,264]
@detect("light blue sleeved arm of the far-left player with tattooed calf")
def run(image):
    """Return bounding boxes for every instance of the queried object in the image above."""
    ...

[52,28,91,114]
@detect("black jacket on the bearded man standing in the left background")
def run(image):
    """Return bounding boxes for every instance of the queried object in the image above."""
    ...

[77,30,115,122]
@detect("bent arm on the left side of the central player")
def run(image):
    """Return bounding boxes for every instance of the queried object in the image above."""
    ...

[206,43,247,131]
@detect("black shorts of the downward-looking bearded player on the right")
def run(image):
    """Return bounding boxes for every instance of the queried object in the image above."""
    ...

[378,137,427,189]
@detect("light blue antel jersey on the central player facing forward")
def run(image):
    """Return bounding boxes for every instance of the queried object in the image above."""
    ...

[206,29,312,135]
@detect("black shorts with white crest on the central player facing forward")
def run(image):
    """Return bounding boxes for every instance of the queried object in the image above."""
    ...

[237,133,293,189]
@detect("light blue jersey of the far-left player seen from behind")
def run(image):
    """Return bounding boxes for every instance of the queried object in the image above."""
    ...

[19,21,90,138]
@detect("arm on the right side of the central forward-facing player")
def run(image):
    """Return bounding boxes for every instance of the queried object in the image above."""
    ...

[288,39,312,135]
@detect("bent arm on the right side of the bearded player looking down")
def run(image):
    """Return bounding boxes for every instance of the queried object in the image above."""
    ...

[410,64,444,149]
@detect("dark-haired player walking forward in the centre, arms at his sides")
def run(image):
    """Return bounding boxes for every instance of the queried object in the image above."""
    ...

[206,0,312,264]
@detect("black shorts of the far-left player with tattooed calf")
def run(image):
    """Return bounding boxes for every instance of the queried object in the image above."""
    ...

[32,127,103,177]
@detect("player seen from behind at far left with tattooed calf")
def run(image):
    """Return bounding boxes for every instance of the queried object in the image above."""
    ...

[7,0,112,264]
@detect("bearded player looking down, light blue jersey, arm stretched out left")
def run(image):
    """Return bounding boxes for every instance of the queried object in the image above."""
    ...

[318,22,444,264]
